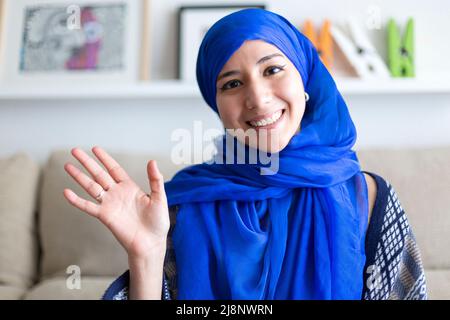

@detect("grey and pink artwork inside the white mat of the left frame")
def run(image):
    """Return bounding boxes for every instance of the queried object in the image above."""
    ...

[19,3,127,73]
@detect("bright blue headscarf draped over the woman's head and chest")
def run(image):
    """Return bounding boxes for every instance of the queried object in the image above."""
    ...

[165,9,368,299]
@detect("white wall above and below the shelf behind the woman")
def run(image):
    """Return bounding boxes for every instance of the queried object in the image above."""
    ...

[0,0,450,162]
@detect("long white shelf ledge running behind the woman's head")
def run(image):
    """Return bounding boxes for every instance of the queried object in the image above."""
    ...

[0,78,450,101]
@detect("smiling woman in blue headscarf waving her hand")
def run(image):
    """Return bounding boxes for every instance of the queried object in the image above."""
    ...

[64,9,426,299]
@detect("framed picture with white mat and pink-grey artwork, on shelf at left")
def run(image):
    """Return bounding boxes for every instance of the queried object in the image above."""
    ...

[1,0,143,85]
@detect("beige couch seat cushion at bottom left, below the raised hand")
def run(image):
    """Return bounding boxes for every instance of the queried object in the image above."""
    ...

[24,277,114,300]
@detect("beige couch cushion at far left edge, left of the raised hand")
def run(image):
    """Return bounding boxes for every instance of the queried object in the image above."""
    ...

[0,153,39,292]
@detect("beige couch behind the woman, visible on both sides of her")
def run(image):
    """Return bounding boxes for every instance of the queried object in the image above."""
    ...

[0,147,450,299]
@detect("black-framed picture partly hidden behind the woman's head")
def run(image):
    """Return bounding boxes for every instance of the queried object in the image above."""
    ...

[178,4,266,82]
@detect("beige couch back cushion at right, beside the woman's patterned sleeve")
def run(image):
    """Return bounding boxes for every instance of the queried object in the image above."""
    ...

[357,147,450,269]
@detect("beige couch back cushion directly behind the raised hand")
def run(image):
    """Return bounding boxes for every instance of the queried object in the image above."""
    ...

[39,148,185,277]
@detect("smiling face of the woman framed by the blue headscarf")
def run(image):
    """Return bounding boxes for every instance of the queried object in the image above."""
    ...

[216,40,305,153]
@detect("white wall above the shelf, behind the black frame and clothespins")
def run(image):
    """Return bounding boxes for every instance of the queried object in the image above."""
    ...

[152,0,450,78]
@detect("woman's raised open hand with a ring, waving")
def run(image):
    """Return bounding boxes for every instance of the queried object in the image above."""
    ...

[63,147,170,257]
